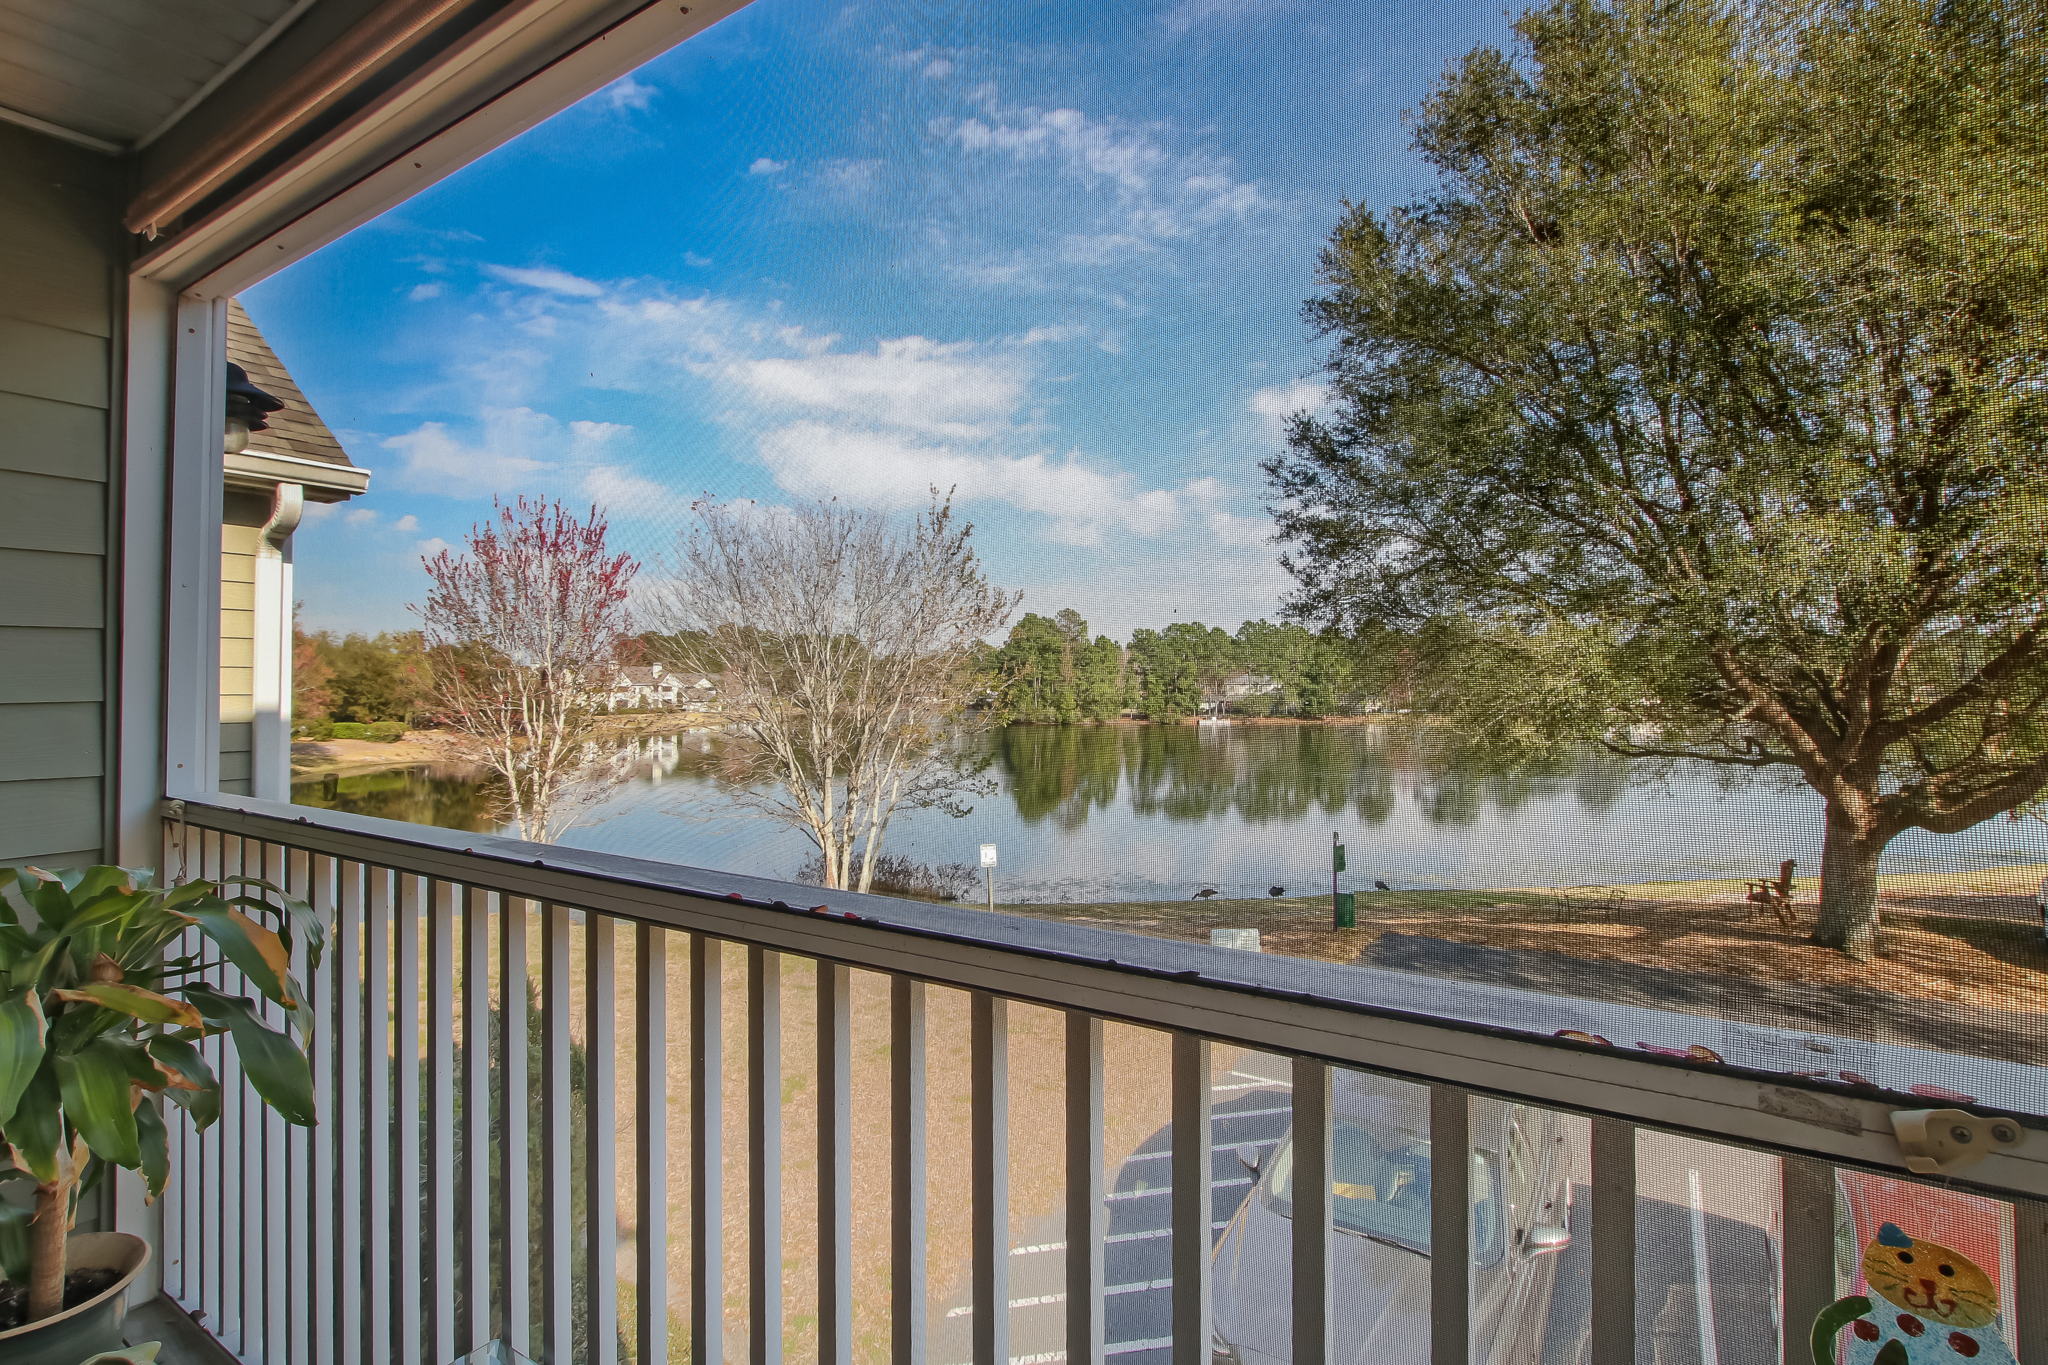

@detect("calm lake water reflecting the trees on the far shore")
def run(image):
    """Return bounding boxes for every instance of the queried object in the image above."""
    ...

[293,724,2048,905]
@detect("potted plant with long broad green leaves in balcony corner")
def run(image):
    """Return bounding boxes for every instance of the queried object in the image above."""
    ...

[0,868,326,1365]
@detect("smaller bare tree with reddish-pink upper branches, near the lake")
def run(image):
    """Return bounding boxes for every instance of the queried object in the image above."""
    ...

[412,497,639,841]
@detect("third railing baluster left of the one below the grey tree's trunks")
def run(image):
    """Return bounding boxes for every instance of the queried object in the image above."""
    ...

[633,925,668,1365]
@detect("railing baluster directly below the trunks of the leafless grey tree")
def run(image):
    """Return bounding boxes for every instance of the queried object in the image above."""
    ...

[817,962,847,1365]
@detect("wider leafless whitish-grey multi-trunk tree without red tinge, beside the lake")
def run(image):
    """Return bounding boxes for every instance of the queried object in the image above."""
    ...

[649,491,1018,890]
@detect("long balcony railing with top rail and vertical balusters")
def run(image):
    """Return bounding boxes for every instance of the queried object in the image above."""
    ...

[151,802,2048,1365]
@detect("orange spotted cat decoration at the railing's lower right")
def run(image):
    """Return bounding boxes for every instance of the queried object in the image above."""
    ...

[1812,1224,2015,1365]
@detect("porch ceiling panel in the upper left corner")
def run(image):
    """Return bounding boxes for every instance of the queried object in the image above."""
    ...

[0,0,307,147]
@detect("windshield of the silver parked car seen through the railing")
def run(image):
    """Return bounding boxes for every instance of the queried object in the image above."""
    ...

[1266,1119,1499,1257]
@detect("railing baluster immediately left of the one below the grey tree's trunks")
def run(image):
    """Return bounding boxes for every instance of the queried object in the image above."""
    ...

[748,948,782,1365]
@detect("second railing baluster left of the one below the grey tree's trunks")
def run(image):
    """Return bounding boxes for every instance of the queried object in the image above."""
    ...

[690,935,725,1365]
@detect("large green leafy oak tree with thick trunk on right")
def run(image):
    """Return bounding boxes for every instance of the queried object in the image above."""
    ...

[1268,0,2048,956]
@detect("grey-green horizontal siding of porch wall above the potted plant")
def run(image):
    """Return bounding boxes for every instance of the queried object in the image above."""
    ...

[0,125,127,864]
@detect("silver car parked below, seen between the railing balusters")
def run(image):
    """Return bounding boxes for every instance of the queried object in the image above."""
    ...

[1212,1072,1571,1365]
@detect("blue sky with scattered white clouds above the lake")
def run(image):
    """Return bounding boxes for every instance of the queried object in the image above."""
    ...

[244,0,1507,636]
